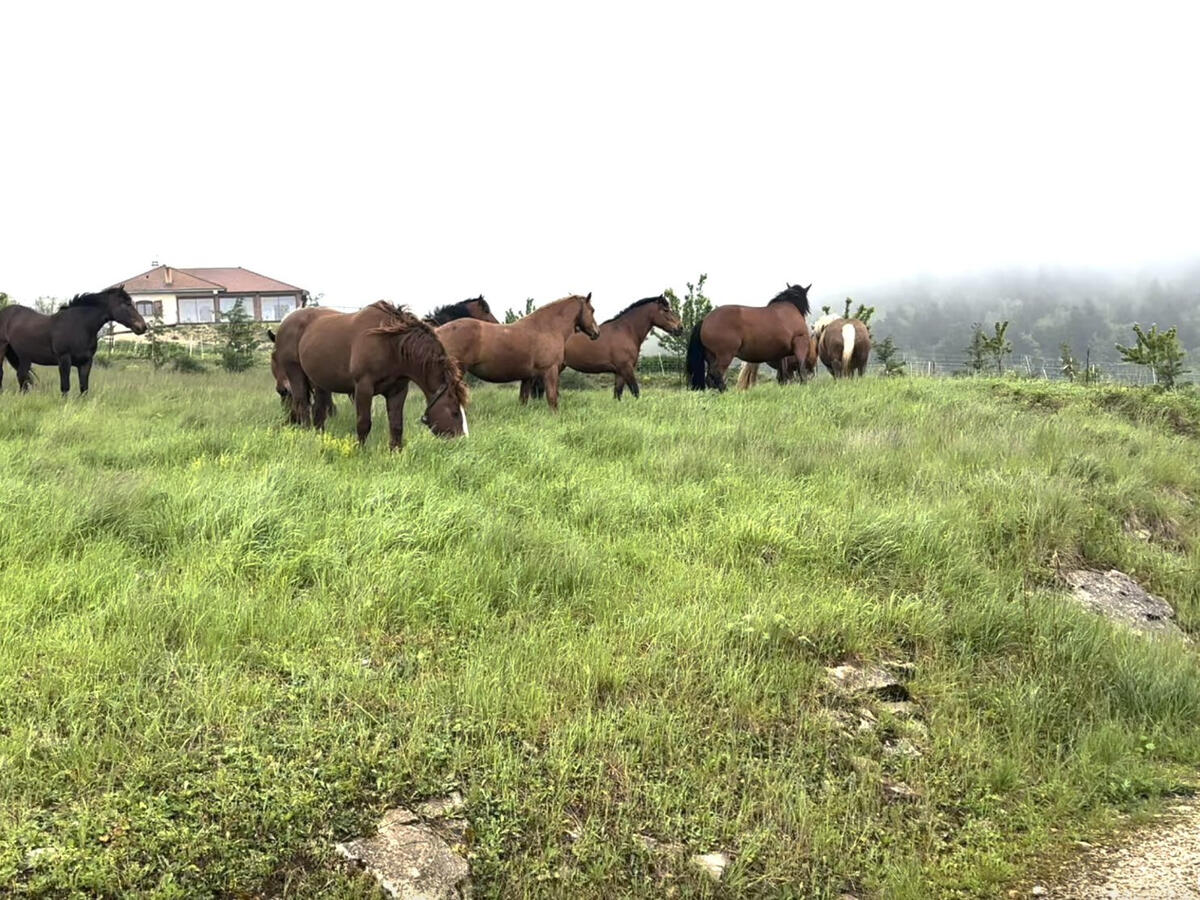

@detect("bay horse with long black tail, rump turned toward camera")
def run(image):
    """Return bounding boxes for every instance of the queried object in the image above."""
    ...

[688,284,812,390]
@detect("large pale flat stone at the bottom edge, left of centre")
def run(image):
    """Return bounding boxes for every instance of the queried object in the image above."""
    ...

[335,808,470,900]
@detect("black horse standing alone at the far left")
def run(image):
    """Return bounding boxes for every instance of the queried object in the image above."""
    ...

[0,284,146,397]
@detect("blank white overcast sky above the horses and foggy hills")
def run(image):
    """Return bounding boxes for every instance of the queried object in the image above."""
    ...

[0,0,1200,312]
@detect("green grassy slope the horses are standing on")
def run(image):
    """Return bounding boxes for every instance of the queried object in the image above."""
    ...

[0,366,1200,898]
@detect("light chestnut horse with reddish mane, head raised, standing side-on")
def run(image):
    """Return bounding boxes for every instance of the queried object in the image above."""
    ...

[437,294,600,410]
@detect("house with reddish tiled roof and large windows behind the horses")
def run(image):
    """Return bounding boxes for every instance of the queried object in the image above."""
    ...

[114,263,308,330]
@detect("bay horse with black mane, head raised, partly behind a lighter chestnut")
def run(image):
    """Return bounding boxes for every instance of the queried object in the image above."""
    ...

[529,296,683,400]
